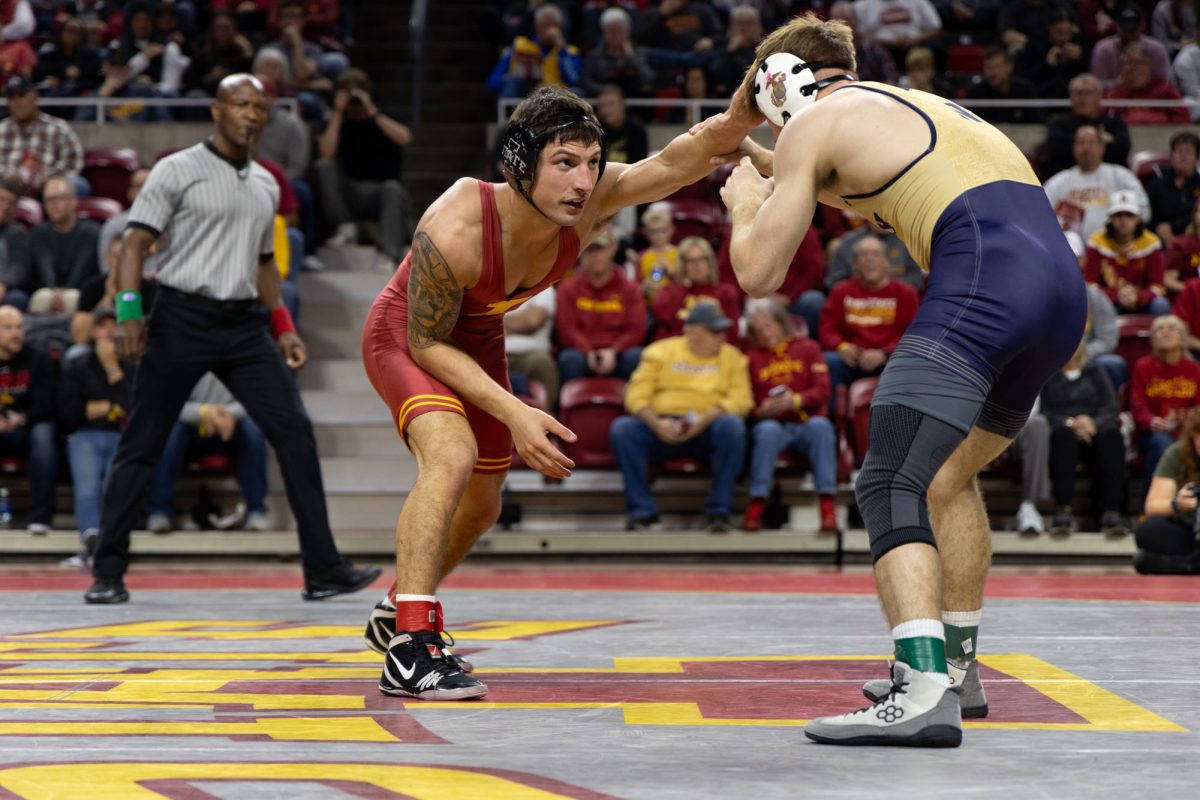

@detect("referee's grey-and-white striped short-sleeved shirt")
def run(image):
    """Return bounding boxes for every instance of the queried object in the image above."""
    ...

[130,143,280,300]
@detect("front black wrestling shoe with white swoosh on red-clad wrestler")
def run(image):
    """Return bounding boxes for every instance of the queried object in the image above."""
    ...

[379,631,487,700]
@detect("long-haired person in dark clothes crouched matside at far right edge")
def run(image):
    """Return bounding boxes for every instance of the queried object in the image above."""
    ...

[1133,410,1200,575]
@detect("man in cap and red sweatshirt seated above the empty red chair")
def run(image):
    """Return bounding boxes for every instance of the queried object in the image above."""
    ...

[554,230,646,384]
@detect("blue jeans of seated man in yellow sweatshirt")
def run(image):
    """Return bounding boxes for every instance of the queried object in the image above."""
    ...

[614,412,746,519]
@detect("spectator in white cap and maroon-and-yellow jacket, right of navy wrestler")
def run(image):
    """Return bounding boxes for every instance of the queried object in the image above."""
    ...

[1084,191,1171,315]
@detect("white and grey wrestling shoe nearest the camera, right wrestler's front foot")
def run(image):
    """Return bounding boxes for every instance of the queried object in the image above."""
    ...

[804,661,962,747]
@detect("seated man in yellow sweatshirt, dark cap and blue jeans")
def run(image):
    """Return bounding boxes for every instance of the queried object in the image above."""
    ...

[608,302,754,533]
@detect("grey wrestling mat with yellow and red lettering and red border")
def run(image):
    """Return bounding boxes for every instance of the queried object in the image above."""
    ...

[0,563,1200,800]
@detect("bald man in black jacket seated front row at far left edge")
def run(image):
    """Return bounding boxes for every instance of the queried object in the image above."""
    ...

[0,306,59,535]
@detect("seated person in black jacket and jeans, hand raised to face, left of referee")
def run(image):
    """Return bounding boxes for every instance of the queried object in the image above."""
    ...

[59,306,136,558]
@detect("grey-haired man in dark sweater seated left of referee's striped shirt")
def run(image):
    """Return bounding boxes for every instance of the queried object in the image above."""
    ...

[29,178,100,314]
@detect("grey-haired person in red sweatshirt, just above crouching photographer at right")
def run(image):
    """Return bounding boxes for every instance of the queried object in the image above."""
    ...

[1129,314,1200,500]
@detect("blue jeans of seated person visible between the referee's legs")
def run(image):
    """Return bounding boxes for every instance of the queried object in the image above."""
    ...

[148,416,266,516]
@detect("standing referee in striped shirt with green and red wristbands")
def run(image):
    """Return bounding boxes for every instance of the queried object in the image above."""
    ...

[84,74,379,603]
